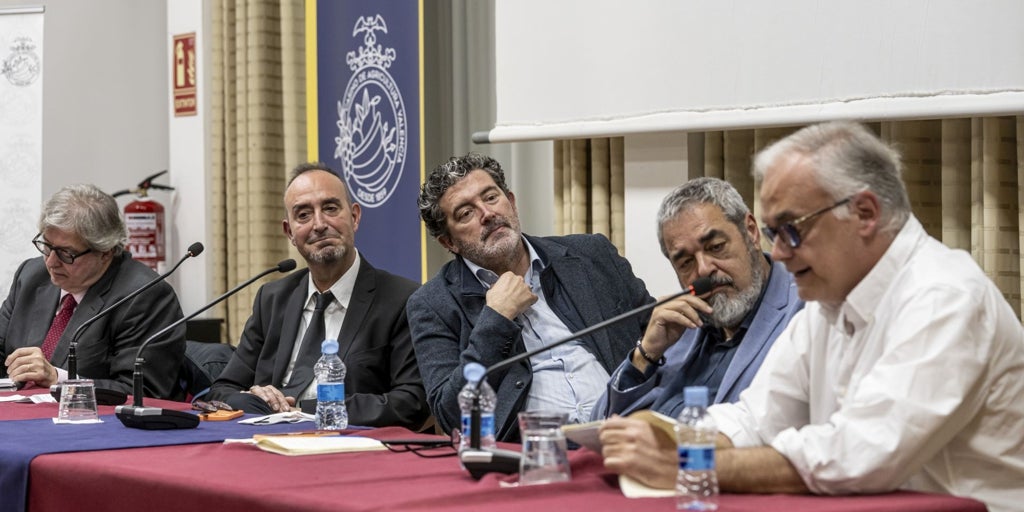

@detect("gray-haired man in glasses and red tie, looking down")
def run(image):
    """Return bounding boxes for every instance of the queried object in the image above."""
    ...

[0,184,185,399]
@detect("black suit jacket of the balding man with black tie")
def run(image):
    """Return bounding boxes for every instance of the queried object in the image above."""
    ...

[210,258,430,430]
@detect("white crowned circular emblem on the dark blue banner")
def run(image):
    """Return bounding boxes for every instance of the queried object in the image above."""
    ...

[334,15,409,208]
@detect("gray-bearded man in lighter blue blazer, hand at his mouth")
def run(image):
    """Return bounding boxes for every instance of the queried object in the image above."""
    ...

[593,178,804,470]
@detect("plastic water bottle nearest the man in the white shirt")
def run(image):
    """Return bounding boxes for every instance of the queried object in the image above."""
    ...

[676,386,718,510]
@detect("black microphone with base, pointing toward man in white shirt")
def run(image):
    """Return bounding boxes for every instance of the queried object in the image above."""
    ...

[459,276,714,479]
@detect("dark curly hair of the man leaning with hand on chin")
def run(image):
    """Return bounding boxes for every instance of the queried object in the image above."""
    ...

[416,153,509,238]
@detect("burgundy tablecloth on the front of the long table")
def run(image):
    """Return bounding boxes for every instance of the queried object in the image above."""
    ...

[29,428,985,512]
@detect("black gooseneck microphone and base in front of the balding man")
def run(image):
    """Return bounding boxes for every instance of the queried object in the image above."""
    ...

[114,259,295,430]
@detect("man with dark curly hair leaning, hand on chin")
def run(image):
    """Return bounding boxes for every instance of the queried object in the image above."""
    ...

[407,154,653,441]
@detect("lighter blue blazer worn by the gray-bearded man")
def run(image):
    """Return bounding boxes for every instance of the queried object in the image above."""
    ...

[591,258,804,419]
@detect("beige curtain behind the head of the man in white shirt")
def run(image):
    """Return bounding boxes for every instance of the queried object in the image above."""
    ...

[690,117,1024,317]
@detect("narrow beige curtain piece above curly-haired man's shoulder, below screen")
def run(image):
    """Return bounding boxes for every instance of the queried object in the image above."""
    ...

[554,137,626,254]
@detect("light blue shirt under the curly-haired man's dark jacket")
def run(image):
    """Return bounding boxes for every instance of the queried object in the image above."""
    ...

[463,239,608,423]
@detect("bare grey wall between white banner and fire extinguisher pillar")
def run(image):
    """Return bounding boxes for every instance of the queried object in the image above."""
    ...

[0,0,178,292]
